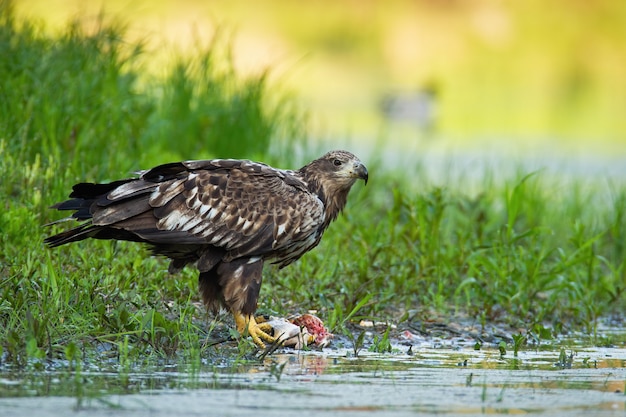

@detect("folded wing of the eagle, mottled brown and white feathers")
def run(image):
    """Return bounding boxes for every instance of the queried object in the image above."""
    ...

[126,160,324,259]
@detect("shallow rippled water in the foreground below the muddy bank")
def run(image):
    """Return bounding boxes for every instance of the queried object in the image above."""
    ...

[0,347,626,417]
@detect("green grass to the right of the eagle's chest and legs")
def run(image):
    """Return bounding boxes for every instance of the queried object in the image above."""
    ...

[270,171,626,332]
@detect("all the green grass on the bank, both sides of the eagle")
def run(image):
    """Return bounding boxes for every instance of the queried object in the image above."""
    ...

[0,3,626,366]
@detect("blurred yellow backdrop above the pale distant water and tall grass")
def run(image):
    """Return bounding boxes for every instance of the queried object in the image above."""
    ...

[15,0,626,158]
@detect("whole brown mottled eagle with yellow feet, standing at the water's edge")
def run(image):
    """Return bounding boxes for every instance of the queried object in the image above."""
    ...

[46,151,368,346]
